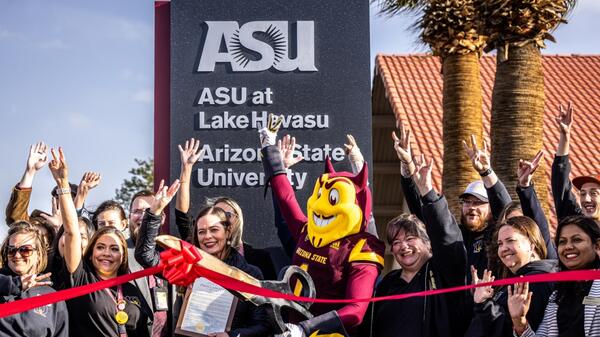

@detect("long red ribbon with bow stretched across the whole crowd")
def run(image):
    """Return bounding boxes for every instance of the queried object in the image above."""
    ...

[0,245,600,318]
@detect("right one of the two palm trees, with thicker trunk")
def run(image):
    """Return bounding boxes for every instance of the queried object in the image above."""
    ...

[477,0,575,211]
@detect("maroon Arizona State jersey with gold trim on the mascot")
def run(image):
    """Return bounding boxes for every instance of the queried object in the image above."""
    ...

[271,174,385,334]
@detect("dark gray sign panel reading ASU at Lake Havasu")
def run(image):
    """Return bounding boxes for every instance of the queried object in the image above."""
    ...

[170,0,371,247]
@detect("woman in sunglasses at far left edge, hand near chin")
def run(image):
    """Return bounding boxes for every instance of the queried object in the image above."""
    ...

[0,221,69,337]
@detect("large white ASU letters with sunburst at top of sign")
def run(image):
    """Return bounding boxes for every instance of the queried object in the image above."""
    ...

[197,21,317,72]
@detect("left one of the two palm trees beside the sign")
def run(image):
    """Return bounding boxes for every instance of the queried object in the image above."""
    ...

[379,0,485,214]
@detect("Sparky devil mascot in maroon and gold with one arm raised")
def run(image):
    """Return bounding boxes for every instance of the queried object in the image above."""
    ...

[259,115,385,337]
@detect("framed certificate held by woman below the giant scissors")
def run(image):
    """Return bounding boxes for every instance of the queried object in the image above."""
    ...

[175,277,237,337]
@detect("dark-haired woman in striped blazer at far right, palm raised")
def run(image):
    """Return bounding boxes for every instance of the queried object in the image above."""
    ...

[508,216,600,337]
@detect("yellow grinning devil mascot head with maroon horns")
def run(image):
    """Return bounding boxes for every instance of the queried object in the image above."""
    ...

[306,160,371,248]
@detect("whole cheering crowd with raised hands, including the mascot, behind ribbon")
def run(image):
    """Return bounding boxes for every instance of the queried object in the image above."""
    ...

[0,104,600,337]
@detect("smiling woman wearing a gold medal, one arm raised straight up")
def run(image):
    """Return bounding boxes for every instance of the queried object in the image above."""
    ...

[49,148,151,337]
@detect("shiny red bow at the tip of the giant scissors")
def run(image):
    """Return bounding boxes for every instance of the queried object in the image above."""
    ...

[160,240,202,287]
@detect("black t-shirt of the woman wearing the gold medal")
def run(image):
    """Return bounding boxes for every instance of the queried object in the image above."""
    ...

[67,261,149,337]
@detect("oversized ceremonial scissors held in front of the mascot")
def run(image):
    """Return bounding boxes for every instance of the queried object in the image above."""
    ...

[156,235,316,334]
